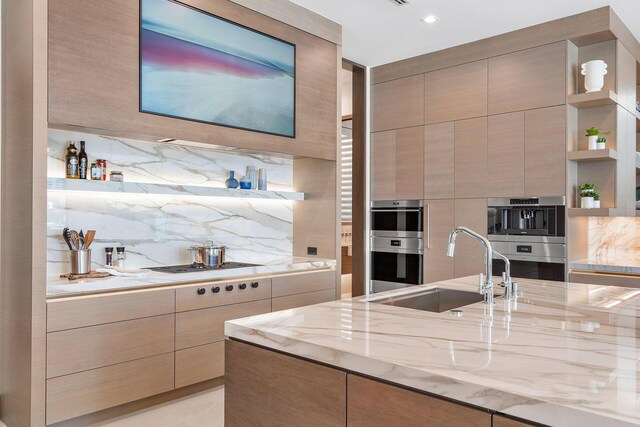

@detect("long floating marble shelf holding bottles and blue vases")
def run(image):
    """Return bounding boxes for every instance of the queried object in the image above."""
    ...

[47,178,304,200]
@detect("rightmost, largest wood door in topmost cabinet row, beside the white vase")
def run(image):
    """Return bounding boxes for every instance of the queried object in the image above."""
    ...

[489,42,567,114]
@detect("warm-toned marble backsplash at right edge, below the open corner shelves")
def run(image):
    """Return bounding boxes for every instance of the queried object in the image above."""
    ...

[589,217,640,261]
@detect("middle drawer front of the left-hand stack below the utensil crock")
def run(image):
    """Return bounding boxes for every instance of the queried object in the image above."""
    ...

[47,314,175,378]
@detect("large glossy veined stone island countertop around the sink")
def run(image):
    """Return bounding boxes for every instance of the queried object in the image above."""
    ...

[225,277,640,427]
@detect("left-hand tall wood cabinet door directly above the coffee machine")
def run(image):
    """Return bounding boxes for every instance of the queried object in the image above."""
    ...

[487,111,525,197]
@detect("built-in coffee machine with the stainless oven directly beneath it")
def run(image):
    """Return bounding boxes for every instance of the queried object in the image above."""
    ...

[487,197,566,281]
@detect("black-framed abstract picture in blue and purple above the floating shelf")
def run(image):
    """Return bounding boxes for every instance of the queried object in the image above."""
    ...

[140,0,296,138]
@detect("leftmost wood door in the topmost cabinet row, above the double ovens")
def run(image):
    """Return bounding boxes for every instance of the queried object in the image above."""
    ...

[371,75,424,132]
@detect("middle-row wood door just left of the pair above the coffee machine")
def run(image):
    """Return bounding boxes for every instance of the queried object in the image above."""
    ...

[455,117,488,198]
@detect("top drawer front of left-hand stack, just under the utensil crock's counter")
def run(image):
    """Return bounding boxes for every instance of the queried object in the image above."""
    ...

[47,289,175,332]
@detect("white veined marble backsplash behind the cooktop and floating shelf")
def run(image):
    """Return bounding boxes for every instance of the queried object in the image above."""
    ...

[47,130,293,274]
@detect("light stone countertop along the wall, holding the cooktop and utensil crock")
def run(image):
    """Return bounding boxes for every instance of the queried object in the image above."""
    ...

[47,257,336,298]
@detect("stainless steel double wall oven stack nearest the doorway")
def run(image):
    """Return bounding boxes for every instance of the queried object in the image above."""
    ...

[371,200,424,293]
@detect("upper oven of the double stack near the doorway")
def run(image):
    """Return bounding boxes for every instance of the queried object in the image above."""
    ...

[371,201,424,238]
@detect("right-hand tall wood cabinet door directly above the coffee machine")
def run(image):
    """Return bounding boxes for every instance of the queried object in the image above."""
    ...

[524,105,567,196]
